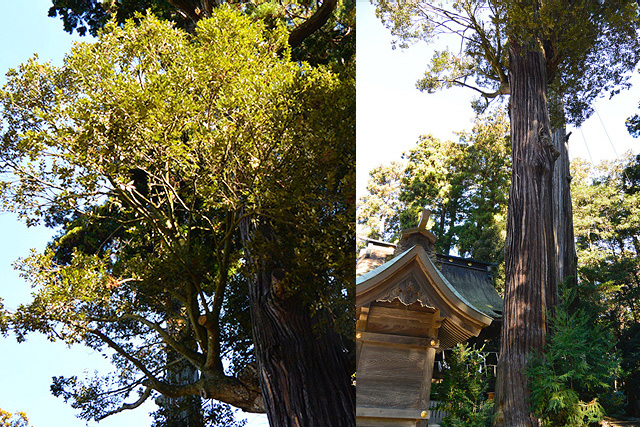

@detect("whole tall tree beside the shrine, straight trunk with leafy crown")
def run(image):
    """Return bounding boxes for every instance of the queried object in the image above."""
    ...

[376,0,638,426]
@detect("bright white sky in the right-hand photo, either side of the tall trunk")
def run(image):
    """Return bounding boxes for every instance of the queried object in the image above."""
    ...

[356,0,640,197]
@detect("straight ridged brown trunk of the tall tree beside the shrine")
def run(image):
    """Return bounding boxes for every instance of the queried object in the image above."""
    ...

[496,41,557,427]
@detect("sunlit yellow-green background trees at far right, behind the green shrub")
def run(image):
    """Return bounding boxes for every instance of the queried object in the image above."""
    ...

[571,155,640,415]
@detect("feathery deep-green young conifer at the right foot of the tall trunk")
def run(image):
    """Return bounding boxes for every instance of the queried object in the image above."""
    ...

[527,289,620,426]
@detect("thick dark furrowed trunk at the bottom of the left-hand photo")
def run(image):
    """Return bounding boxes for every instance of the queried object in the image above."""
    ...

[240,218,355,427]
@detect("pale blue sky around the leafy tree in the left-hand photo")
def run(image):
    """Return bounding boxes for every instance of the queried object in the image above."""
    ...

[0,0,268,427]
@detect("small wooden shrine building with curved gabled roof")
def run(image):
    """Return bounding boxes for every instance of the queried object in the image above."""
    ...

[356,210,502,427]
